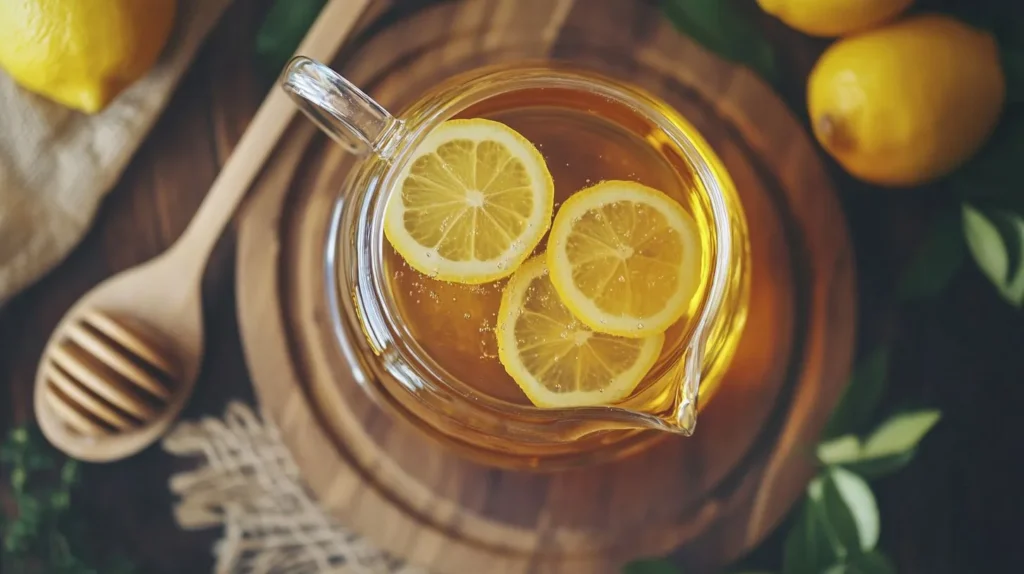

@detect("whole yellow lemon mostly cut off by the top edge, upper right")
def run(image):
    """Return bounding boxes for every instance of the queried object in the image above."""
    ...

[758,0,913,38]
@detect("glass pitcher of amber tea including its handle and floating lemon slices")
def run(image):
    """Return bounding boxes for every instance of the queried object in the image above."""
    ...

[284,57,750,470]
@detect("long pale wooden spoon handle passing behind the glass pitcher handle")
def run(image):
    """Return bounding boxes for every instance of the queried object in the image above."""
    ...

[171,0,370,268]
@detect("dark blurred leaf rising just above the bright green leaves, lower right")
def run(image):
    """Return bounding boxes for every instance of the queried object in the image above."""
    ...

[824,348,889,439]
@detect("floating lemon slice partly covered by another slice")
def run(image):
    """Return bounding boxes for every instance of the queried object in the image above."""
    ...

[495,256,665,407]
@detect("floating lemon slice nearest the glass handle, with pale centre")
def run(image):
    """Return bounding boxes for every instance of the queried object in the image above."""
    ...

[384,119,555,284]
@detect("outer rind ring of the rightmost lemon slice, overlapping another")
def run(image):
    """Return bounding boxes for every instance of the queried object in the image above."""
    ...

[547,180,700,338]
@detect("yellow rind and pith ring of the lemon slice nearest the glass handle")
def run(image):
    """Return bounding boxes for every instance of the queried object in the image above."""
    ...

[384,119,555,284]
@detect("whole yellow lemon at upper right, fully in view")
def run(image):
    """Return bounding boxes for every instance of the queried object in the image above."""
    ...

[807,14,1006,187]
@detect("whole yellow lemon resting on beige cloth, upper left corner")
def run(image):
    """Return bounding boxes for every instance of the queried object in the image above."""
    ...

[0,0,176,114]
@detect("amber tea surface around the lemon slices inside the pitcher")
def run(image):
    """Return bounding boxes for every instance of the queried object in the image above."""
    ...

[384,83,738,408]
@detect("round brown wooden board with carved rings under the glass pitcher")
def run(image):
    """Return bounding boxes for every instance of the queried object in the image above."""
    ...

[238,0,855,574]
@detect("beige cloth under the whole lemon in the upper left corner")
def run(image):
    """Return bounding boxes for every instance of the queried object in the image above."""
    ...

[0,0,230,307]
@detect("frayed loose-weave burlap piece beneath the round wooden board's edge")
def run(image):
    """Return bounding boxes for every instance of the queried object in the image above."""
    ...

[163,402,425,574]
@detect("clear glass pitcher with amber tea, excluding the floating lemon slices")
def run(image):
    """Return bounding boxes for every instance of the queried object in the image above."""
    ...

[282,56,750,470]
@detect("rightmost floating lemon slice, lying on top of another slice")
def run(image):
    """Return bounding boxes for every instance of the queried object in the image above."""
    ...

[547,180,701,337]
